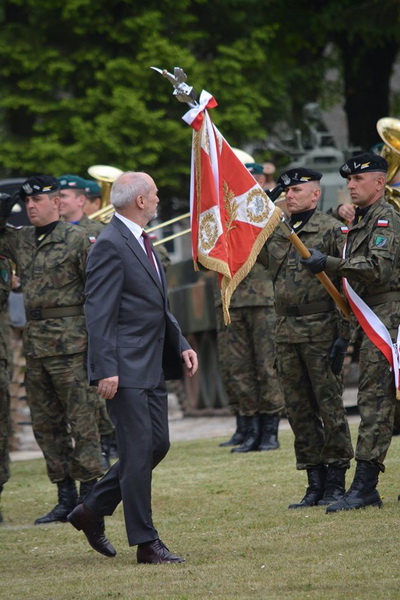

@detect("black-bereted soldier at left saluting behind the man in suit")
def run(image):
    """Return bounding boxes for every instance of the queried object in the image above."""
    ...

[0,175,102,524]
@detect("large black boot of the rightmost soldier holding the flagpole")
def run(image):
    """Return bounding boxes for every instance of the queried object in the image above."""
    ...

[326,460,382,513]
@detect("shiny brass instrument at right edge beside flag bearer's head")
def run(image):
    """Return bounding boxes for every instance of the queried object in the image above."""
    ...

[376,117,400,212]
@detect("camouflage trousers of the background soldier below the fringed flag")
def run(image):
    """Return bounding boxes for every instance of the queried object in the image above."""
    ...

[217,306,284,416]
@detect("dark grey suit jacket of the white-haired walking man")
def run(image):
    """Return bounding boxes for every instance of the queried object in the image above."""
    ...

[85,216,190,389]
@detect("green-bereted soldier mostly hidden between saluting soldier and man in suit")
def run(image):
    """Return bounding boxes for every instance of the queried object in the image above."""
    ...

[57,174,115,470]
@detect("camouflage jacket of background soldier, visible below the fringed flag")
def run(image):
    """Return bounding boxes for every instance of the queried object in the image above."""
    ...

[214,262,274,308]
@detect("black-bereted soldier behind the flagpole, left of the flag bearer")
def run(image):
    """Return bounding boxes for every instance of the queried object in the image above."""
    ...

[259,168,353,508]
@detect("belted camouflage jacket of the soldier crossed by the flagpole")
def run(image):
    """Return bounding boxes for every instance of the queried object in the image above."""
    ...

[259,210,350,343]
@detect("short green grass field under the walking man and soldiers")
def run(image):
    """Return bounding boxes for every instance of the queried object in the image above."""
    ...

[0,426,400,600]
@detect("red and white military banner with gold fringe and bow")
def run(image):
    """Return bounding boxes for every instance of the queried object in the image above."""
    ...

[183,91,282,323]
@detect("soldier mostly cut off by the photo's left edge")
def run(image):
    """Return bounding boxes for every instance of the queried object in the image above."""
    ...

[0,256,12,523]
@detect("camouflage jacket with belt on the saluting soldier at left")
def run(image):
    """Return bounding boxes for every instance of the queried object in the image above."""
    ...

[0,221,91,358]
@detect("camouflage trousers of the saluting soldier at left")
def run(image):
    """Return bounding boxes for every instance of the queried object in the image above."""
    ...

[25,353,103,483]
